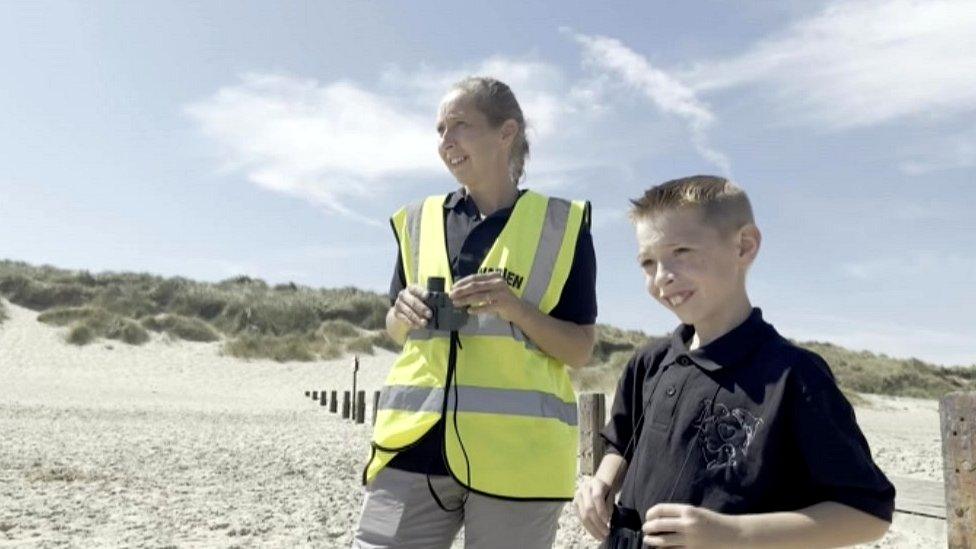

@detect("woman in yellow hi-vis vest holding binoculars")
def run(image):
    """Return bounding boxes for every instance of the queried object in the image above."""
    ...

[354,77,596,548]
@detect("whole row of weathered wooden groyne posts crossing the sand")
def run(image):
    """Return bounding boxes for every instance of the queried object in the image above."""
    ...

[305,378,976,549]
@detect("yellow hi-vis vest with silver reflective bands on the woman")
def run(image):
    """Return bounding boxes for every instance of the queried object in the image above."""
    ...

[363,191,588,500]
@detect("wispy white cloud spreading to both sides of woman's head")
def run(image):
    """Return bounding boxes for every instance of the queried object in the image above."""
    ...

[185,56,698,217]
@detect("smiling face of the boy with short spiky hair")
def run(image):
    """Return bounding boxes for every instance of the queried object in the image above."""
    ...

[634,208,758,326]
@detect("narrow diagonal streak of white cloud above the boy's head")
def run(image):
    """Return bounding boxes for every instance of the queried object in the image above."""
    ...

[563,29,732,175]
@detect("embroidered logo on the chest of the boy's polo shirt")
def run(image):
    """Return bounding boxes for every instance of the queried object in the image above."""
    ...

[695,399,763,478]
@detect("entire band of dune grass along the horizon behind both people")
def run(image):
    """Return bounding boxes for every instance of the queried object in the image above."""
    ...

[0,260,976,398]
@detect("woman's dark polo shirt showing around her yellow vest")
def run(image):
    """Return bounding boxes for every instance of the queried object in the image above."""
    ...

[389,187,596,475]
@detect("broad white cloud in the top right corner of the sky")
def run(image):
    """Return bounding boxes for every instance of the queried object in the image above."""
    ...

[683,0,976,129]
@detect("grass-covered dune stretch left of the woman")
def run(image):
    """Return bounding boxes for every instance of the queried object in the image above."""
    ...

[0,261,392,361]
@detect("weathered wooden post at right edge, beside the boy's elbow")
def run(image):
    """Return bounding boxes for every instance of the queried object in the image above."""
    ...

[939,393,976,549]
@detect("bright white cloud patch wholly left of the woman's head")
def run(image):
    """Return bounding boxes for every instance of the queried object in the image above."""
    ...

[186,74,441,221]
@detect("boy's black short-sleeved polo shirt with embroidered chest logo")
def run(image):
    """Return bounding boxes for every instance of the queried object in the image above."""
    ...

[602,309,895,521]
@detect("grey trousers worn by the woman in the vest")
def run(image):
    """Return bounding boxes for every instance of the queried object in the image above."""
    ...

[352,467,565,549]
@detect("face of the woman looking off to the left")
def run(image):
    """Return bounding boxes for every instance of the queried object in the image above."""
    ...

[437,90,511,187]
